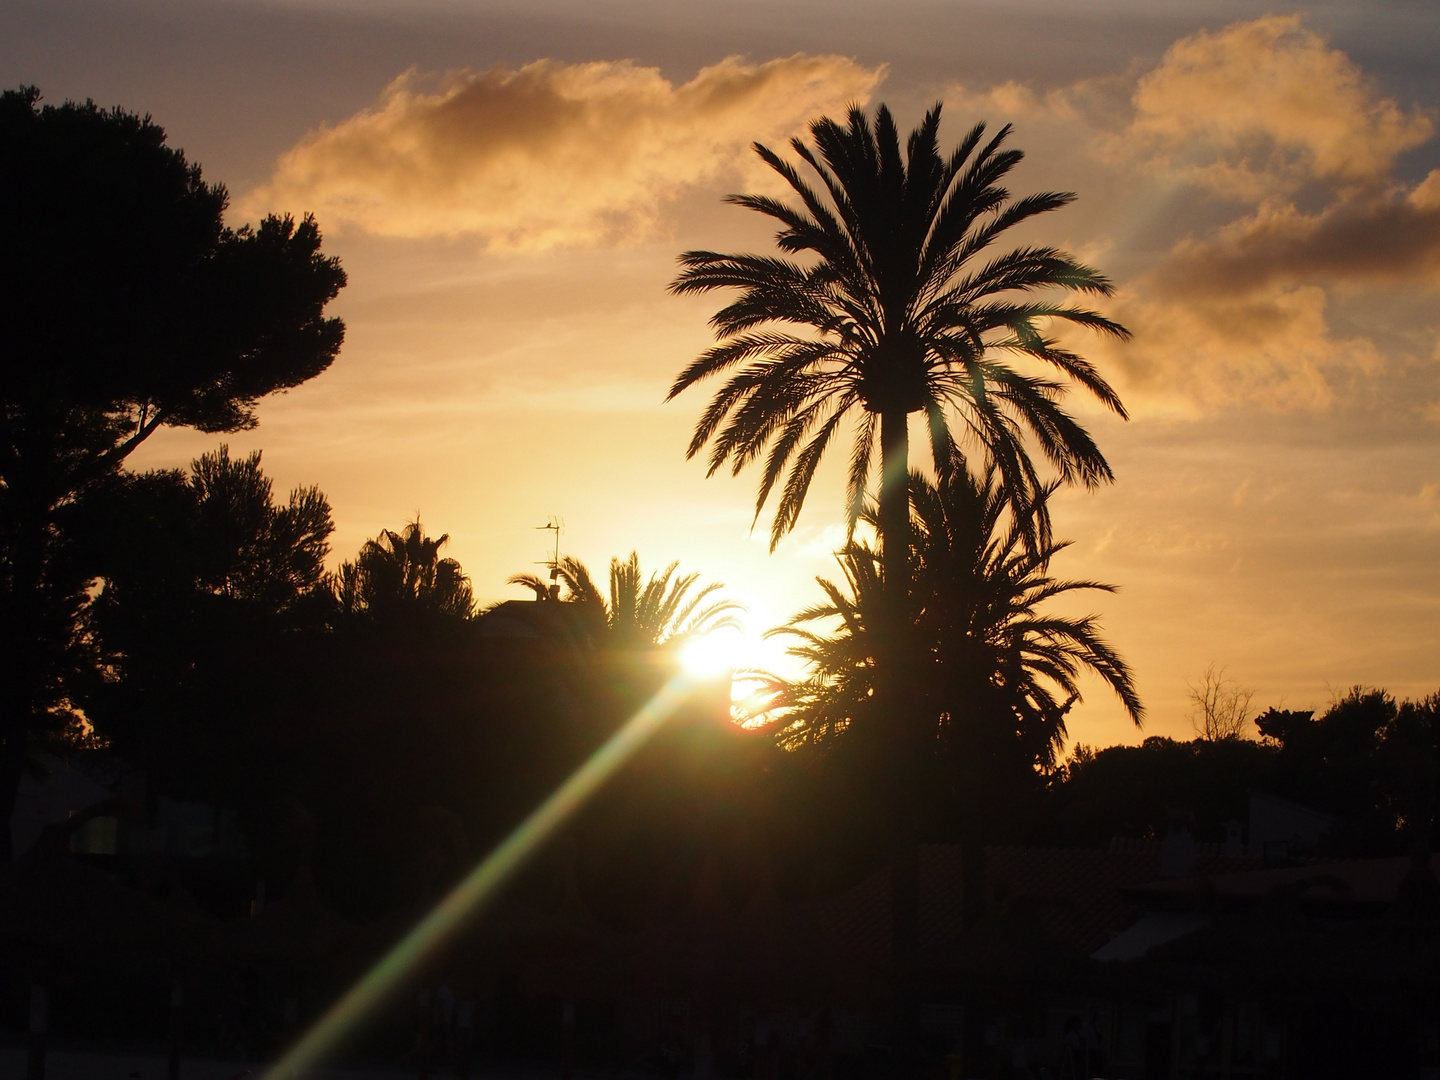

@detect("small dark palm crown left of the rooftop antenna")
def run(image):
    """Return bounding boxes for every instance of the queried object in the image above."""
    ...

[334,521,475,619]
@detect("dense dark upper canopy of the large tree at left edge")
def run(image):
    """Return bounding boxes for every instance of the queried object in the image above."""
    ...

[0,88,346,486]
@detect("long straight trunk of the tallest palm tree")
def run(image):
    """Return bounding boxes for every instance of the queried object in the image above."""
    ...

[876,409,922,1077]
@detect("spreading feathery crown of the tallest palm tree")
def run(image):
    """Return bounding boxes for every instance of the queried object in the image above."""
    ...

[667,104,1128,570]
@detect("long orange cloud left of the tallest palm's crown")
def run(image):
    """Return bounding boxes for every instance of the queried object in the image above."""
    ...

[242,55,884,248]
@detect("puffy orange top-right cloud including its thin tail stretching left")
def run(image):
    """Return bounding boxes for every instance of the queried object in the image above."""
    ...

[946,14,1434,203]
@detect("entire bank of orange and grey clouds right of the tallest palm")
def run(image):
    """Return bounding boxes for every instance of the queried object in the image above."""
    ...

[953,16,1440,415]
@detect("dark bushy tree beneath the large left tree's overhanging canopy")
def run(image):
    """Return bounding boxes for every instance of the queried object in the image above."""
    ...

[78,445,334,791]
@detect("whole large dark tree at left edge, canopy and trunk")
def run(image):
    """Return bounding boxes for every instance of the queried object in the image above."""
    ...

[0,88,346,858]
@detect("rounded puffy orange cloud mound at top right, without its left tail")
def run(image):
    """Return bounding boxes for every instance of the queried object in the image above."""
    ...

[1110,16,1434,200]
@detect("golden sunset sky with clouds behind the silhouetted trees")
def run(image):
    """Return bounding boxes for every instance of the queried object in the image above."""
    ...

[11,0,1440,743]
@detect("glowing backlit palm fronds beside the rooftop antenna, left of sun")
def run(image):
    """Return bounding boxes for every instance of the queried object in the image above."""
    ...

[508,552,743,648]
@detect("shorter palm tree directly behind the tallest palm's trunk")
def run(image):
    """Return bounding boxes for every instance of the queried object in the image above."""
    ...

[770,462,1143,920]
